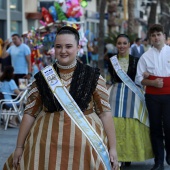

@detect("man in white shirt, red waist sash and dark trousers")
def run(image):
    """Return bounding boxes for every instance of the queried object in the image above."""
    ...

[135,24,170,170]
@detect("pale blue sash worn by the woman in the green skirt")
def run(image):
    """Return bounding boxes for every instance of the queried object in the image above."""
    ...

[110,55,145,103]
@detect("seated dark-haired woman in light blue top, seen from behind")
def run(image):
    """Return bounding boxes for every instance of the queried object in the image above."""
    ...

[0,66,20,126]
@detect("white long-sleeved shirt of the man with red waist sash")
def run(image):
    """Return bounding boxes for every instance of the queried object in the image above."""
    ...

[135,45,170,85]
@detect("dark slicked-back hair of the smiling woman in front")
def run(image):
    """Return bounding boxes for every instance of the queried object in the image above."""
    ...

[56,26,80,44]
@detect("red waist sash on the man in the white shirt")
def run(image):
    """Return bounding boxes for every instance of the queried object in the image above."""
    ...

[146,75,170,95]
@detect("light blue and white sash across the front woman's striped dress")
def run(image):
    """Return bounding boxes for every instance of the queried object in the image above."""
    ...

[41,66,111,170]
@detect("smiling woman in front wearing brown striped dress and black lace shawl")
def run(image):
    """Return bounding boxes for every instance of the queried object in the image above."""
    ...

[4,26,119,170]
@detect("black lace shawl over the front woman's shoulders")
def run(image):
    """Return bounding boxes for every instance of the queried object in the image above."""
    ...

[34,62,100,112]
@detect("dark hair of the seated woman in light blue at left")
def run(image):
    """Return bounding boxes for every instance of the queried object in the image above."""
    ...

[0,66,14,82]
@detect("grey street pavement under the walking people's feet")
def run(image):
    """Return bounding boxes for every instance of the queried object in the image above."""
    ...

[0,125,170,170]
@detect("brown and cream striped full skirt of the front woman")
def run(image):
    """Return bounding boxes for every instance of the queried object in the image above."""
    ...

[3,111,107,170]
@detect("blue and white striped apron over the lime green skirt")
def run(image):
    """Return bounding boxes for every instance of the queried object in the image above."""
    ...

[109,83,149,126]
